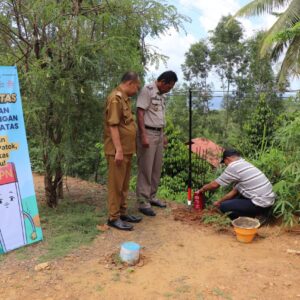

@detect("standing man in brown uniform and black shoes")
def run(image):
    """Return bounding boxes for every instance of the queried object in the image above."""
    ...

[104,72,142,230]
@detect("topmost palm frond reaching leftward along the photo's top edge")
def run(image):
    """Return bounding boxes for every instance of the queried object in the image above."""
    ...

[233,0,290,18]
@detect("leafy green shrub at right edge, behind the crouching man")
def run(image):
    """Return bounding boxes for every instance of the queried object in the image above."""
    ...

[254,116,300,226]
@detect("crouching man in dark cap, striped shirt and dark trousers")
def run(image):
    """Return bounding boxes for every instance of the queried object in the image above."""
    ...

[199,149,275,223]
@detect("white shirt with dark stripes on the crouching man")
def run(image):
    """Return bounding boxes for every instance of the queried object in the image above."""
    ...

[215,158,275,207]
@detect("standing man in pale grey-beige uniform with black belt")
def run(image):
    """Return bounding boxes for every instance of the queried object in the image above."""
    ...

[136,71,178,216]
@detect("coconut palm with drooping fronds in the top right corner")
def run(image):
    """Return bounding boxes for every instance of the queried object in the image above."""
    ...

[234,0,300,83]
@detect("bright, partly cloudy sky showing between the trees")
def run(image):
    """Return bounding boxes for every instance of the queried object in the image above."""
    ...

[146,0,300,89]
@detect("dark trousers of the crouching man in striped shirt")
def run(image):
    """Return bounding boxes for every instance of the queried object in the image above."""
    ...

[220,196,271,220]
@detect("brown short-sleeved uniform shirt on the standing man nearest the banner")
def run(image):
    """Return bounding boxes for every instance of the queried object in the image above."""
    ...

[104,88,136,155]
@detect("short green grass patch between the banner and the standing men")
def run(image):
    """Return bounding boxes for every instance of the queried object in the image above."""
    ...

[39,200,106,261]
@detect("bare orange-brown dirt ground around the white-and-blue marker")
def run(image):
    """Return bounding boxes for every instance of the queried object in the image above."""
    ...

[0,176,300,300]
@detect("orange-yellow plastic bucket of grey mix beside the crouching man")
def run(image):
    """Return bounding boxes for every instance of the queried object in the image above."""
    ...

[231,217,260,243]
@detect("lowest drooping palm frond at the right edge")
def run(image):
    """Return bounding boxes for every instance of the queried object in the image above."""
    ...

[279,36,300,83]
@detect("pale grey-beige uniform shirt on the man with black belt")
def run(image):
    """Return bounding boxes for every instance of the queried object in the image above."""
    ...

[136,82,166,128]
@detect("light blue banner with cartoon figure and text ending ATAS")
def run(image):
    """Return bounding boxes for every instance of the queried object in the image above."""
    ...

[0,66,43,253]
